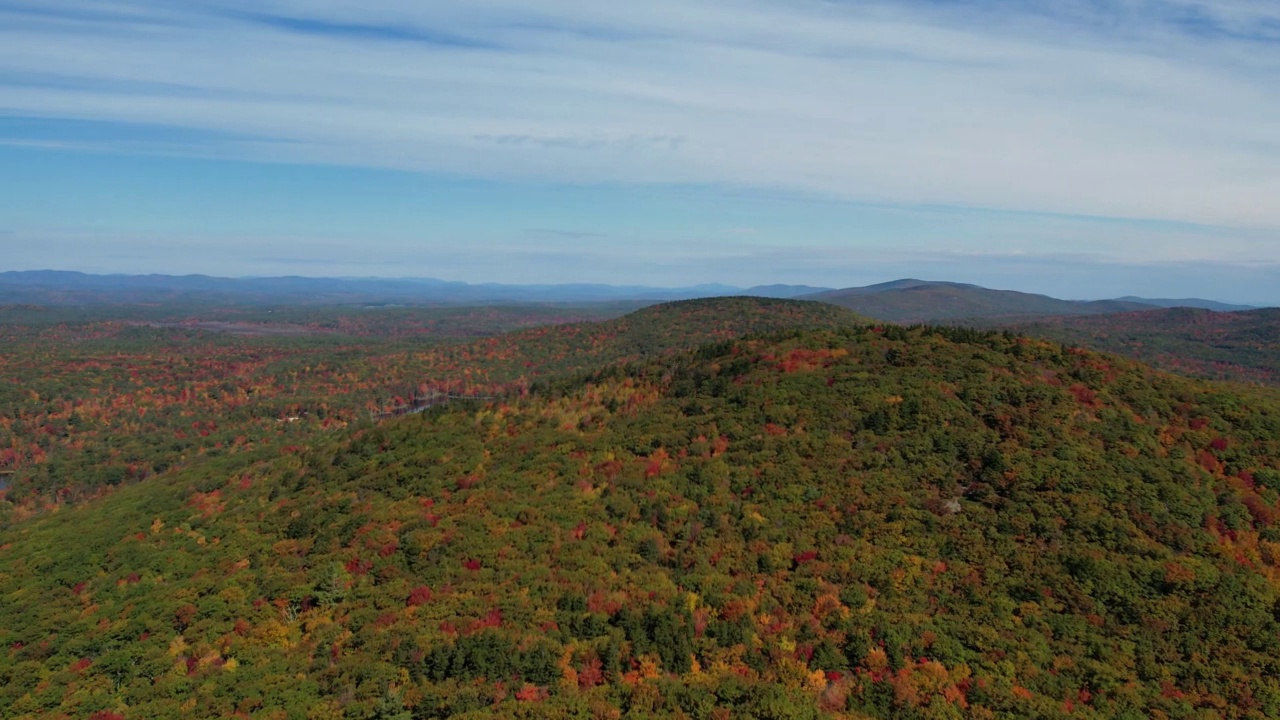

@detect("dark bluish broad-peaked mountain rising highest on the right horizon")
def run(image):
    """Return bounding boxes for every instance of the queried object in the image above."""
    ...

[805,279,1151,323]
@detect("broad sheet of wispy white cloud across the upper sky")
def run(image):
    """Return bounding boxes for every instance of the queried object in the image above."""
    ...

[0,0,1280,238]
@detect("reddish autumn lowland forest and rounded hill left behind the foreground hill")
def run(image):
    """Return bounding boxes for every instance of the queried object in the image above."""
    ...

[0,299,861,515]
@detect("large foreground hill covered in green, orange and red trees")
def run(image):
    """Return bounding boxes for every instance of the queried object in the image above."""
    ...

[0,327,1280,720]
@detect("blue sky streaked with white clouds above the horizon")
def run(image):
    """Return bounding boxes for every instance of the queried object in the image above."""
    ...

[0,0,1280,304]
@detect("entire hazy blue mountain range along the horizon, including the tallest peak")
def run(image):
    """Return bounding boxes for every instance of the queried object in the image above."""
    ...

[0,270,1248,316]
